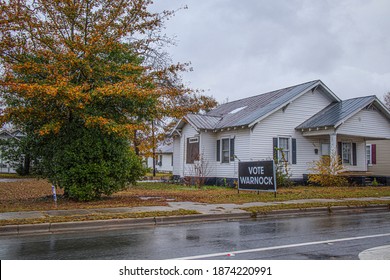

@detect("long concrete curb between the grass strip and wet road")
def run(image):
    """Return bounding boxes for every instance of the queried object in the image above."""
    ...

[0,204,390,236]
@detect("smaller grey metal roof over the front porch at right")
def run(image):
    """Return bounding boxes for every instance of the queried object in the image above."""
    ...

[296,95,376,129]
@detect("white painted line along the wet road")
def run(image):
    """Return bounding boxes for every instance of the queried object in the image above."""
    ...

[174,233,390,260]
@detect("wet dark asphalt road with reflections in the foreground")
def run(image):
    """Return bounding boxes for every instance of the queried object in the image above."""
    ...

[0,212,390,260]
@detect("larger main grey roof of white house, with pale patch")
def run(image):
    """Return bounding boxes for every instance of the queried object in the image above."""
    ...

[185,80,339,129]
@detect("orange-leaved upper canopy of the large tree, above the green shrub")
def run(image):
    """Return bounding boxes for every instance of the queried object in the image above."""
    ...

[0,0,219,153]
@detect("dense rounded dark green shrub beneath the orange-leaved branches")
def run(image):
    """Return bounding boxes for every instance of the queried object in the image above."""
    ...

[42,127,144,201]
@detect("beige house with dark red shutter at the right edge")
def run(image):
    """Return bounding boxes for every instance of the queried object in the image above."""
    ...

[366,140,390,176]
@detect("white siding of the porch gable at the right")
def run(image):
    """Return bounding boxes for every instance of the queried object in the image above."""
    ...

[337,110,390,138]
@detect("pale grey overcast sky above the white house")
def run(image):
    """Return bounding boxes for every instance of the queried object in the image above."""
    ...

[154,0,390,102]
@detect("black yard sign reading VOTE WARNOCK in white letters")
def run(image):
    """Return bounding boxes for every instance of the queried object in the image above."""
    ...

[238,160,276,193]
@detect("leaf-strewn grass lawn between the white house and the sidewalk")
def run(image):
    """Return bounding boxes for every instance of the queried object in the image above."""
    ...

[0,179,390,212]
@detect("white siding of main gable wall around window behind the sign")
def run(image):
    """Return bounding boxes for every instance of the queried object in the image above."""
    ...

[249,88,330,179]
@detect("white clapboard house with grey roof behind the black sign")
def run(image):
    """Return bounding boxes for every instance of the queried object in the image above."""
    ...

[170,80,390,184]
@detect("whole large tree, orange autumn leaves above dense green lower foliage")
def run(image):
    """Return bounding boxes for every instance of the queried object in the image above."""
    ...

[0,0,215,200]
